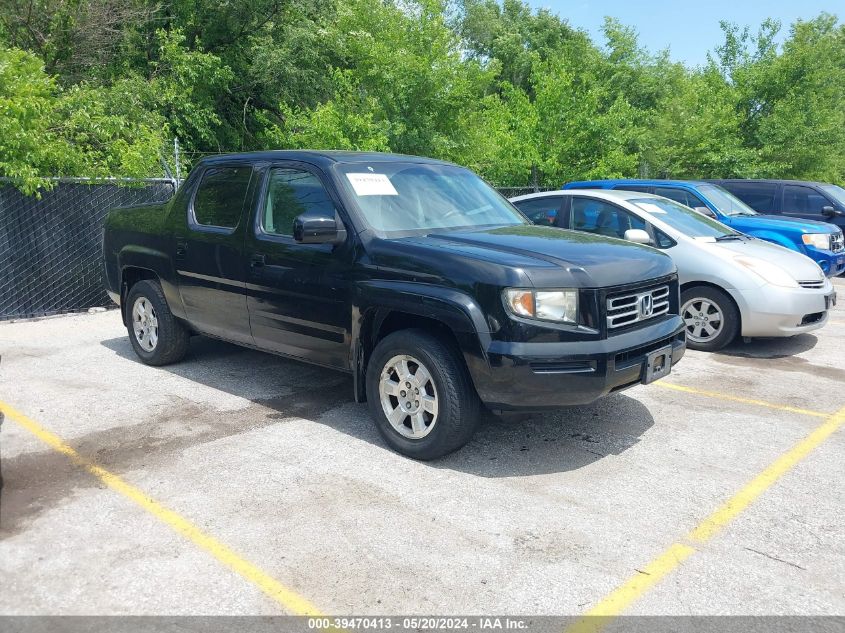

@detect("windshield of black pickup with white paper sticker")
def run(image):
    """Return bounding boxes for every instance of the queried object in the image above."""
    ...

[338,162,528,233]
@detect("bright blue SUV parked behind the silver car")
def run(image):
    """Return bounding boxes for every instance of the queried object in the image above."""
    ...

[563,180,845,277]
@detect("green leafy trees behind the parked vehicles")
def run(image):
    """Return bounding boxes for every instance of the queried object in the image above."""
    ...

[0,0,845,192]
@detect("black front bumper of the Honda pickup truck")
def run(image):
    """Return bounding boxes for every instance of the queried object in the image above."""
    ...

[470,315,686,411]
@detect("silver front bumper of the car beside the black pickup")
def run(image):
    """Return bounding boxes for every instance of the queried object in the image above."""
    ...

[730,279,836,337]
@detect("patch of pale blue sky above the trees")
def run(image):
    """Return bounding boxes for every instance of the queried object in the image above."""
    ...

[527,0,845,66]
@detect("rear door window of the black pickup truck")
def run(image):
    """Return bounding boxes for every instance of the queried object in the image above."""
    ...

[191,165,252,229]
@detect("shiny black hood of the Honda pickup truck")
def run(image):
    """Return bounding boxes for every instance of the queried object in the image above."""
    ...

[386,225,675,288]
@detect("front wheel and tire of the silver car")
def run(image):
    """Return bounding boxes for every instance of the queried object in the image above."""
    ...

[681,286,740,352]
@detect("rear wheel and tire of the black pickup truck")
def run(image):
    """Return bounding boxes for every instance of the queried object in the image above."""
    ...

[124,280,191,366]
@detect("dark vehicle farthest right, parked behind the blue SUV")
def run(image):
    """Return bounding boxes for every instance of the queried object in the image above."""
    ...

[709,179,845,229]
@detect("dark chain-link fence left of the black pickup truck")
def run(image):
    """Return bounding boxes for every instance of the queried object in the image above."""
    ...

[0,179,175,320]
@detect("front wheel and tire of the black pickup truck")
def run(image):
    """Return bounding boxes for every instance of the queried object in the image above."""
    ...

[366,329,481,460]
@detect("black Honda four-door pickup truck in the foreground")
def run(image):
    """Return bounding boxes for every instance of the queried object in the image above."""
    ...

[103,151,685,459]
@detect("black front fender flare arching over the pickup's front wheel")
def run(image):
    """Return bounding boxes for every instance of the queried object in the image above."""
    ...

[350,280,491,402]
